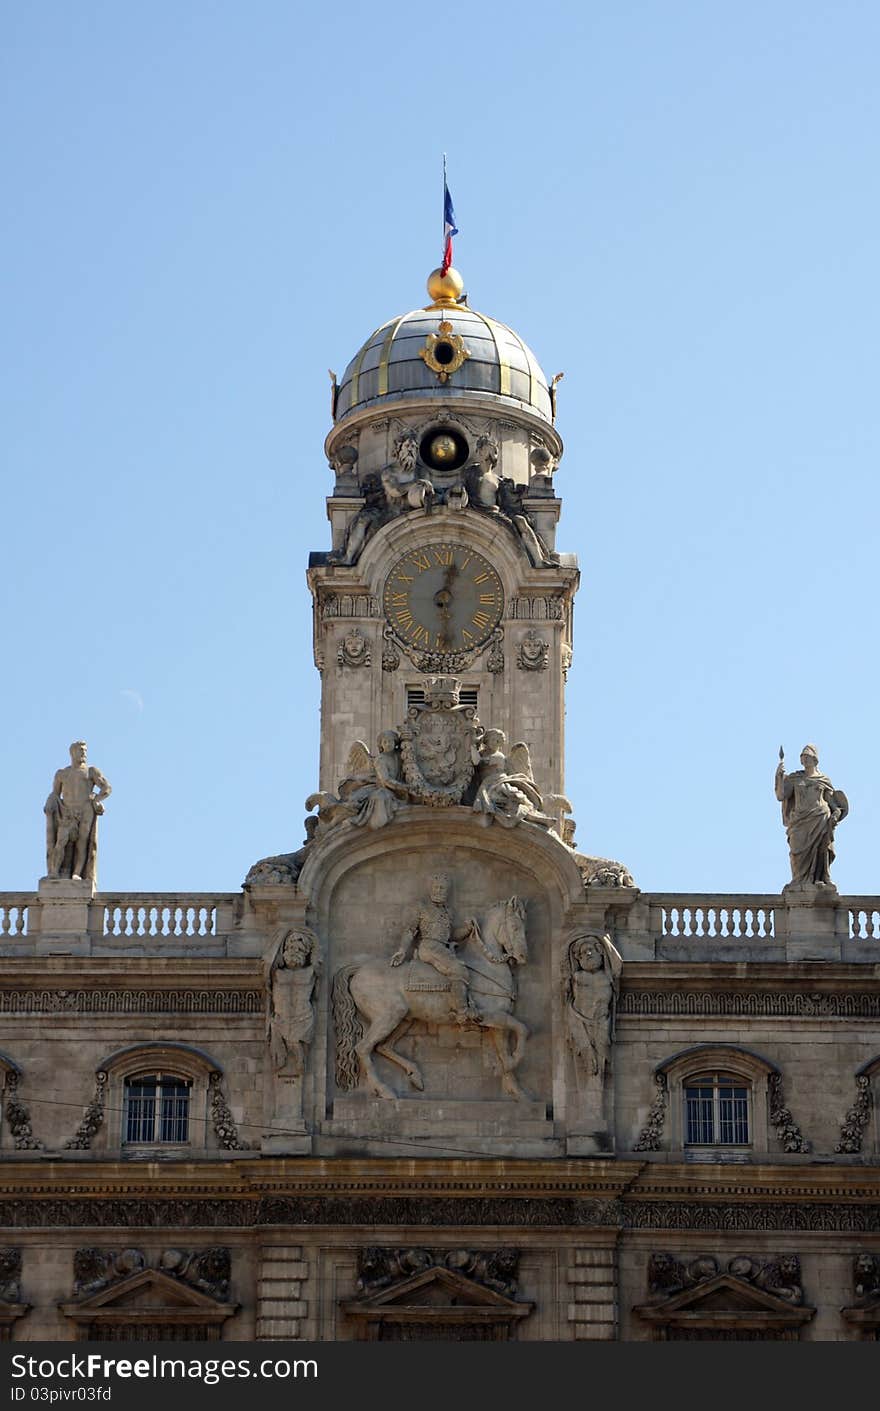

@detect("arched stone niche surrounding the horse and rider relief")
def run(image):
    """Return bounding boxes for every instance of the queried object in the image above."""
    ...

[299,807,582,1156]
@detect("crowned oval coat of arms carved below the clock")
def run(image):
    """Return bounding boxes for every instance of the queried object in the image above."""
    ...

[401,677,479,809]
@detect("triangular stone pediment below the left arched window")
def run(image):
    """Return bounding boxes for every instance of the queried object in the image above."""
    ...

[59,1268,238,1339]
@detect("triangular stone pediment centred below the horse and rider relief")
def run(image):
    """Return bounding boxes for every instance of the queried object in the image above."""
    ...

[341,1266,534,1342]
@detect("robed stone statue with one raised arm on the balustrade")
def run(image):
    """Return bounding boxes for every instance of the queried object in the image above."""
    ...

[774,745,849,890]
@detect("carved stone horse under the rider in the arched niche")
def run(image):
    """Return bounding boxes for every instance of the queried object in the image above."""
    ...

[333,896,529,1098]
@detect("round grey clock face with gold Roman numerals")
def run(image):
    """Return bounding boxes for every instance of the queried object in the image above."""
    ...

[384,543,503,652]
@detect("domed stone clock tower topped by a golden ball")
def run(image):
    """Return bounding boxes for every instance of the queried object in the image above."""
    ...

[309,268,578,824]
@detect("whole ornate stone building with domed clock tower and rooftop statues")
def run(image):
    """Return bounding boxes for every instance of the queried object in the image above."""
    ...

[0,271,880,1340]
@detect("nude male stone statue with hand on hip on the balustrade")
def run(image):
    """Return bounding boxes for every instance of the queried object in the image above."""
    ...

[42,739,111,882]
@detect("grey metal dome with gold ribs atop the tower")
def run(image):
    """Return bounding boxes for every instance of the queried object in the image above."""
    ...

[336,271,553,425]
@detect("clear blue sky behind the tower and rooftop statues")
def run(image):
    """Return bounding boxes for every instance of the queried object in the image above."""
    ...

[0,0,880,892]
